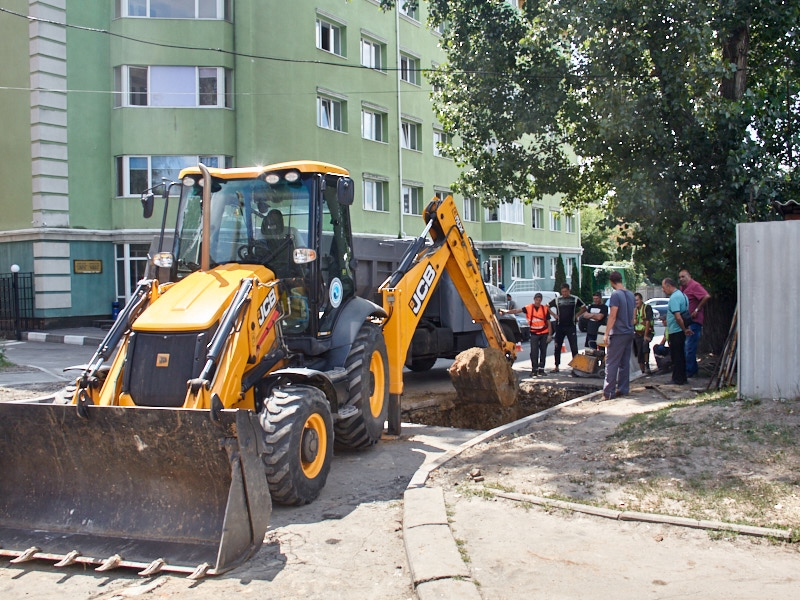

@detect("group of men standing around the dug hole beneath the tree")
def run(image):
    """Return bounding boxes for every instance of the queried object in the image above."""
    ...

[501,269,711,400]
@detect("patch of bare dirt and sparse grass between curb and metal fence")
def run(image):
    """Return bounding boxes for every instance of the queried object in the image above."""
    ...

[431,375,800,537]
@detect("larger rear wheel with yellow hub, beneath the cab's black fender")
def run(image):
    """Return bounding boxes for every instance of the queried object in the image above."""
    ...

[334,323,389,450]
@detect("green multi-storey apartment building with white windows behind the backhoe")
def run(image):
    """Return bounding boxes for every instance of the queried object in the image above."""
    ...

[0,0,581,326]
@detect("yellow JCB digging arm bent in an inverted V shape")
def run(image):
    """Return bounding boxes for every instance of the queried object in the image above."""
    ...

[378,196,516,433]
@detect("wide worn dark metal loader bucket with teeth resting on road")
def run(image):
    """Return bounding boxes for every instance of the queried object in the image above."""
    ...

[0,403,272,578]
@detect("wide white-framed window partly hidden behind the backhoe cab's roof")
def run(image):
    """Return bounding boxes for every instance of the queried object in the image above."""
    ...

[116,155,227,197]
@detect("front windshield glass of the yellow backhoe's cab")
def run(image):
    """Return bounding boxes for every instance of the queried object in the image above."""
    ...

[175,173,311,277]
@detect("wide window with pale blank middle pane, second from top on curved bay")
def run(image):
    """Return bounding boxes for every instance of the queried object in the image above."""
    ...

[114,65,233,108]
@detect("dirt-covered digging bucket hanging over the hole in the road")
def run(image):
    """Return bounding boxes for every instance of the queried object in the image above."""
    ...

[449,348,518,406]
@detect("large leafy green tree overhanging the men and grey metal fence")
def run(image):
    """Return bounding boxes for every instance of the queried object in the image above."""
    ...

[378,0,800,346]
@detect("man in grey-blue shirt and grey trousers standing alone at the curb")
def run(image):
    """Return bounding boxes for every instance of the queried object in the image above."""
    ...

[603,271,636,400]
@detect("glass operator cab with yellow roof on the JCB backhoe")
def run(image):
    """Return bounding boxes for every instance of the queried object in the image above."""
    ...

[172,161,355,346]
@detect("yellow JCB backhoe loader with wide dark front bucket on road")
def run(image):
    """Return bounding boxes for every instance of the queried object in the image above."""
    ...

[0,161,514,578]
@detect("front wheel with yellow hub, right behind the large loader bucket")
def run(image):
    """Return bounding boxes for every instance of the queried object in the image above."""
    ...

[259,385,333,506]
